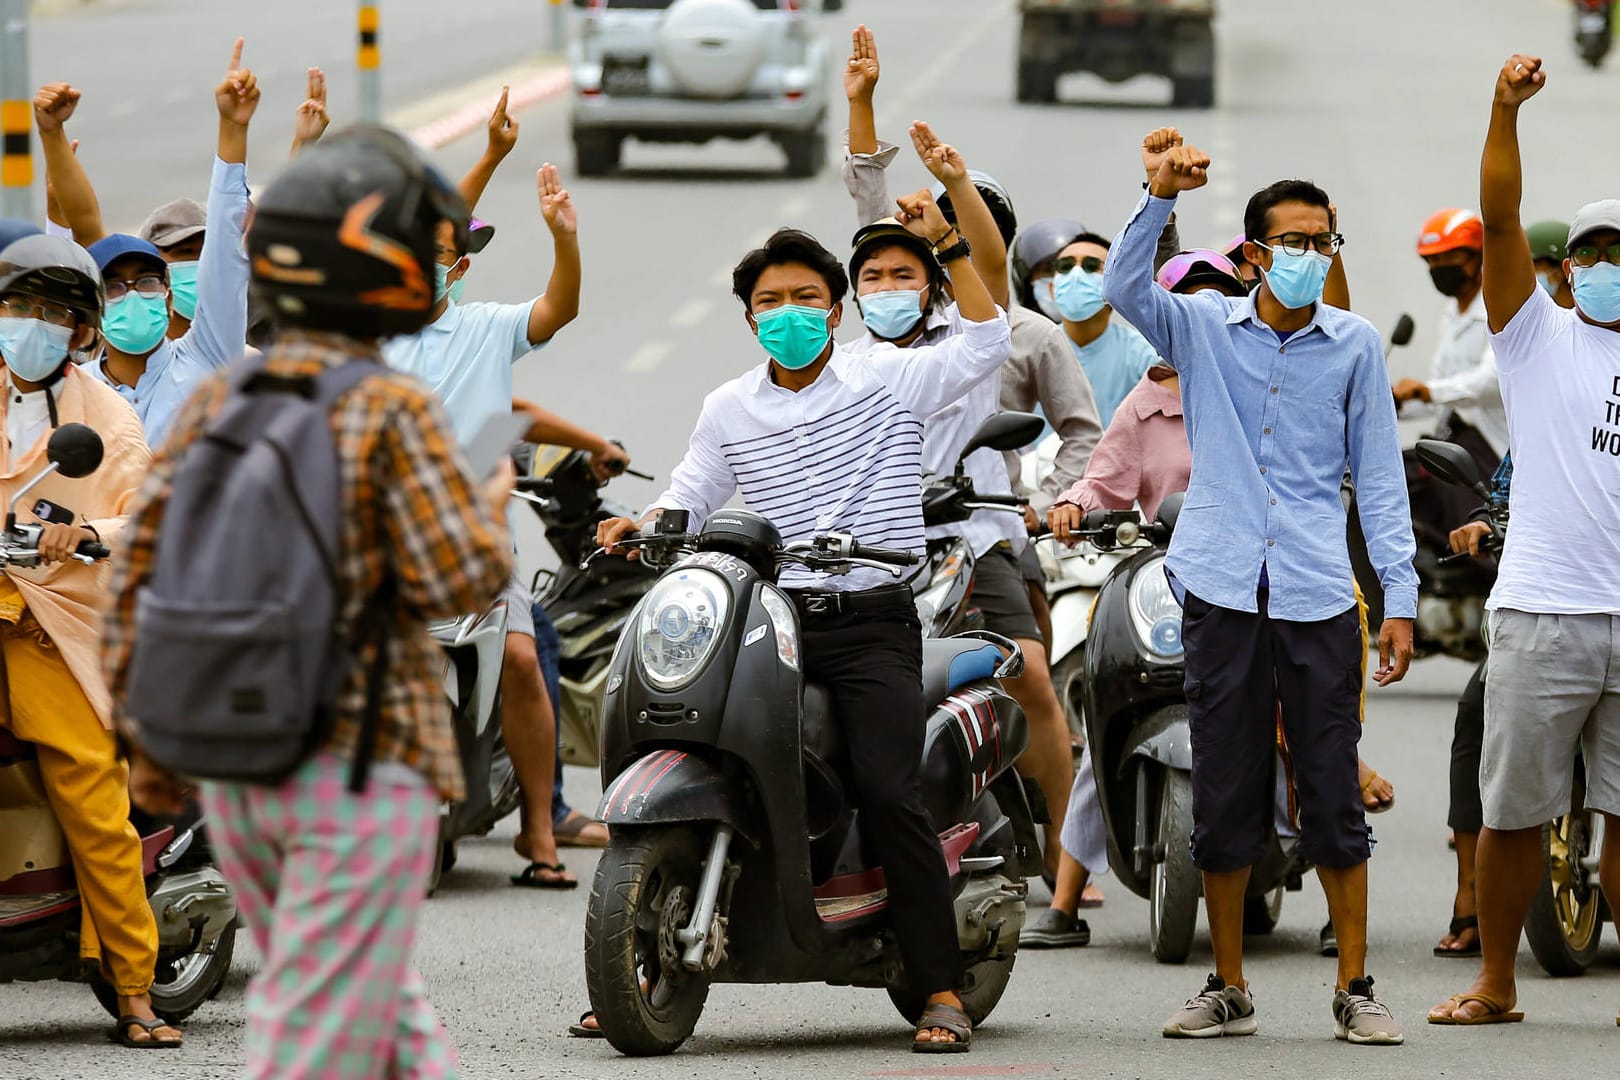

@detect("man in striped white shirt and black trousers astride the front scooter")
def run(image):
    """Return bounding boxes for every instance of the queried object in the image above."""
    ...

[596,191,1011,1052]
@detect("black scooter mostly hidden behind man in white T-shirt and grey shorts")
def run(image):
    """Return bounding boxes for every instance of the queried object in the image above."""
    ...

[1418,439,1614,976]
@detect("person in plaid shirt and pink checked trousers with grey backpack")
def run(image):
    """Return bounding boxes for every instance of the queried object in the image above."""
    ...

[104,128,512,1077]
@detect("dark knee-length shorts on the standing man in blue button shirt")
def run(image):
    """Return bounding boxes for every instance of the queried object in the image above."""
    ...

[1181,589,1372,873]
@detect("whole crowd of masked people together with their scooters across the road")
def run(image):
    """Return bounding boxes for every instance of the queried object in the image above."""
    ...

[0,12,1620,1077]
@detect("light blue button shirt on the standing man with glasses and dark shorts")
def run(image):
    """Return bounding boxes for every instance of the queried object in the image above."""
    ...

[1105,196,1418,622]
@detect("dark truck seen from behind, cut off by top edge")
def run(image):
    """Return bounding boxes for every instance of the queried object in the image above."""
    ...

[1017,0,1215,108]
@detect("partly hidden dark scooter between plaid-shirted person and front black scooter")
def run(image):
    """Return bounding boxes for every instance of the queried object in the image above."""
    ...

[517,444,658,767]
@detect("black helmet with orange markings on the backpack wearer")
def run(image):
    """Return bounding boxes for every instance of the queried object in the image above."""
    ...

[248,125,468,340]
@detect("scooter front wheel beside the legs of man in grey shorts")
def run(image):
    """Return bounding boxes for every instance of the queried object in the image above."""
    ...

[1524,811,1604,978]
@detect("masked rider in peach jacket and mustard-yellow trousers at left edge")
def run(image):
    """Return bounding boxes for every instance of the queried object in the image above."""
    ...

[0,236,162,1048]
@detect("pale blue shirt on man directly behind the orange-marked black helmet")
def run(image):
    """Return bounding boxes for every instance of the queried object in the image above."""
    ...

[382,301,538,447]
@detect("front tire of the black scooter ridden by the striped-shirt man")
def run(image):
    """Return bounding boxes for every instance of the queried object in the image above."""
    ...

[585,826,709,1057]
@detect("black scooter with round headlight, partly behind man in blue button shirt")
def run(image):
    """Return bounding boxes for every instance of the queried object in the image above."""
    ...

[1079,495,1307,963]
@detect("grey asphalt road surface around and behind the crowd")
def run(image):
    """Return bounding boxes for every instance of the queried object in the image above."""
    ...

[0,0,1620,1080]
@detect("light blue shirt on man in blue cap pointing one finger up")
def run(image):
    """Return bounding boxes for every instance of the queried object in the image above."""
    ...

[87,157,248,450]
